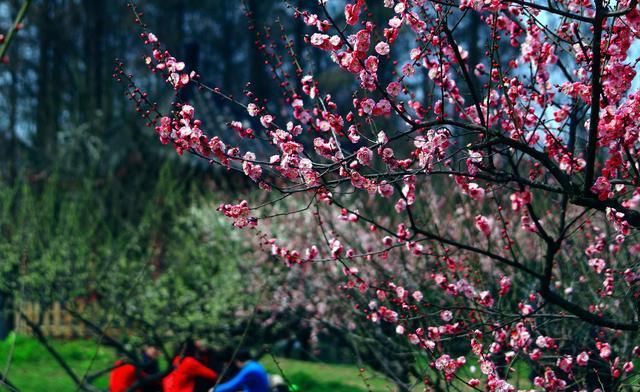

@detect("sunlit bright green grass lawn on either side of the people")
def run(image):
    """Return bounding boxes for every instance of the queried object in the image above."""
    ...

[0,336,531,392]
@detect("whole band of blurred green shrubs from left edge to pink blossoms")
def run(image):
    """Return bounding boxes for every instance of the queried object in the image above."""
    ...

[0,163,255,350]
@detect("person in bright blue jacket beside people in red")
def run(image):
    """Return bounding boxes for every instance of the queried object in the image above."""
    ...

[209,349,271,392]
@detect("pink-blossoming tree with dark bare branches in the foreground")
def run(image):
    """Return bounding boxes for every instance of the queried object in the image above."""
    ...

[121,0,640,391]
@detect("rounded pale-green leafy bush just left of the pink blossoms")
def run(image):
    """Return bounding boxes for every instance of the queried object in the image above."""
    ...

[100,199,254,341]
